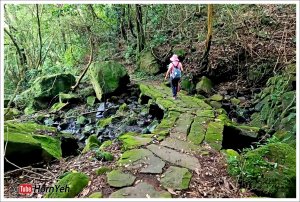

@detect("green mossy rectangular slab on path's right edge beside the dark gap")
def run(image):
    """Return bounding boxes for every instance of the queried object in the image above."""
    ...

[205,122,224,150]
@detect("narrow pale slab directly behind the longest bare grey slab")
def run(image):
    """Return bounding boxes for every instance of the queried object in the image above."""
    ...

[160,137,203,153]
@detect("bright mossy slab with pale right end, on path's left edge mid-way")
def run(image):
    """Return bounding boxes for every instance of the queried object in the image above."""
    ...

[118,132,153,150]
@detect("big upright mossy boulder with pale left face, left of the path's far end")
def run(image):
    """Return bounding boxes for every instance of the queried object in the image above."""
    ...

[89,61,129,100]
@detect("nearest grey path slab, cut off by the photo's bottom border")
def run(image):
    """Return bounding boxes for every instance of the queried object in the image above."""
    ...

[109,182,172,198]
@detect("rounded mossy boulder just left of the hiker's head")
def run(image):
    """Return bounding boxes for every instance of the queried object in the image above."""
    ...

[138,50,160,75]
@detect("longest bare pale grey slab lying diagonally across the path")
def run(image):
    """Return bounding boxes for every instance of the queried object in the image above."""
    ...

[147,144,200,170]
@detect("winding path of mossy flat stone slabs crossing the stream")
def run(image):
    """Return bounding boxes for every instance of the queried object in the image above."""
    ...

[107,84,231,198]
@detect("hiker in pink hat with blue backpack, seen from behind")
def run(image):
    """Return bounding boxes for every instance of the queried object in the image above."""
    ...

[165,54,183,100]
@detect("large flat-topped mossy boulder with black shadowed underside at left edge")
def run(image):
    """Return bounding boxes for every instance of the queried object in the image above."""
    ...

[4,121,62,166]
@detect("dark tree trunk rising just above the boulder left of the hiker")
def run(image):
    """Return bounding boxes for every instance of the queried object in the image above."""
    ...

[135,4,145,53]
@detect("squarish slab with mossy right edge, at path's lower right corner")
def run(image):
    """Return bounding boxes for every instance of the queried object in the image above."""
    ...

[160,166,192,190]
